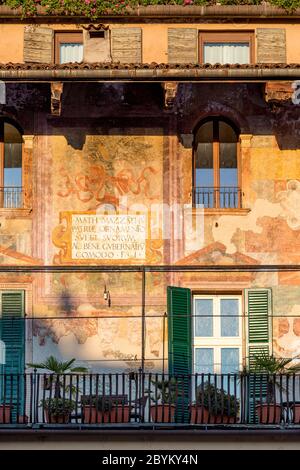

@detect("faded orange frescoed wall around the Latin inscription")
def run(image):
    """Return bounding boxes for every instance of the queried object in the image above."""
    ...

[0,77,300,371]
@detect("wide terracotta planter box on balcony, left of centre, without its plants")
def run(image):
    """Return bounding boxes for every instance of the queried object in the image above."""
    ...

[82,405,130,424]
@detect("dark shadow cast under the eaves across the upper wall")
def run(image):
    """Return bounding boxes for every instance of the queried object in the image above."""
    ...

[2,83,300,150]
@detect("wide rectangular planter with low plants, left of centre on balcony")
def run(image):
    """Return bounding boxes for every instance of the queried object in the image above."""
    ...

[81,395,130,424]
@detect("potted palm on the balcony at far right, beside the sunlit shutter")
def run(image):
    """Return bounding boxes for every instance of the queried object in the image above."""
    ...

[249,352,300,424]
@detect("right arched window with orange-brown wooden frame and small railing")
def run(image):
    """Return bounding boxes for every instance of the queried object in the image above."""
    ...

[193,118,241,209]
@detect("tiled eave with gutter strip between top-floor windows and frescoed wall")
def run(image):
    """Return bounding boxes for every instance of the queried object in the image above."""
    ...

[0,63,300,83]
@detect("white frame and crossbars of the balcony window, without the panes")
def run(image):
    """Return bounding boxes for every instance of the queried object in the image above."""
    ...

[192,293,244,374]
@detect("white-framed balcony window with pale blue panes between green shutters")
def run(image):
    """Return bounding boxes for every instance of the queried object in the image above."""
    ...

[193,295,242,374]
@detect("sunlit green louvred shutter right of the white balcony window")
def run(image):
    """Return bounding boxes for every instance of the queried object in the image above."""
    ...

[245,289,272,422]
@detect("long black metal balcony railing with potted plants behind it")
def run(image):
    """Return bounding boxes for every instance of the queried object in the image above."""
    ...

[0,371,300,429]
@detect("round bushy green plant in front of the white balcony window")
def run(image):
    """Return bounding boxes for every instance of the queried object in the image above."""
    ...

[196,382,240,417]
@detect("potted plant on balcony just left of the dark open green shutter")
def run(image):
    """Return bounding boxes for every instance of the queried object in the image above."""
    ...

[150,377,178,423]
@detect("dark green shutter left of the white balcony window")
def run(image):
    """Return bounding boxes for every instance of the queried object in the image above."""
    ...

[167,287,192,422]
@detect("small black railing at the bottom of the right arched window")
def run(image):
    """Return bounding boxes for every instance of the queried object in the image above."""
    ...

[193,186,242,209]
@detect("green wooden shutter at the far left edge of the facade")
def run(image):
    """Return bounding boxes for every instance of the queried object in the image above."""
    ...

[0,291,25,420]
